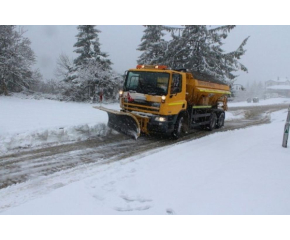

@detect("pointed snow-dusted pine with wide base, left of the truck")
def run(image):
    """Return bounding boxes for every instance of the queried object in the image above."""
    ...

[56,25,121,101]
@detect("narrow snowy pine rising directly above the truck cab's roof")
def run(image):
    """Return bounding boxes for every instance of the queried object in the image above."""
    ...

[137,25,166,64]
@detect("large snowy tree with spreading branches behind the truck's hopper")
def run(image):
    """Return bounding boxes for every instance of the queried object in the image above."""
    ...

[140,25,248,83]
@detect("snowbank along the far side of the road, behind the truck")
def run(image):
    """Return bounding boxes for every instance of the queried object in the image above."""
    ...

[0,94,290,154]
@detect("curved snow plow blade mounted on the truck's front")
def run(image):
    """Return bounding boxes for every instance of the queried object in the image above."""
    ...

[93,106,140,139]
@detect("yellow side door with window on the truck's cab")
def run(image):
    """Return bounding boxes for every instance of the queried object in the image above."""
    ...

[168,73,186,114]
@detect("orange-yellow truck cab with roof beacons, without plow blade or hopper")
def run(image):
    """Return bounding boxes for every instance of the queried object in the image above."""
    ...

[120,65,187,135]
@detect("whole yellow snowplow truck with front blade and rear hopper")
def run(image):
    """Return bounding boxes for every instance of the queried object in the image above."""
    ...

[95,65,230,139]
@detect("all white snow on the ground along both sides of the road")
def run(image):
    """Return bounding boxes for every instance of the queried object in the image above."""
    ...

[0,93,290,236]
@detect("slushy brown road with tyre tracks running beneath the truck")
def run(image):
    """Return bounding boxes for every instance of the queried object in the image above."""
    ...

[0,102,284,192]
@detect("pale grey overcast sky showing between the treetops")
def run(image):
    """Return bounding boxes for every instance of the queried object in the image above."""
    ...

[23,25,290,85]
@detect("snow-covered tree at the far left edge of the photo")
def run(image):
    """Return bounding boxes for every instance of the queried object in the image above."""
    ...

[0,25,35,95]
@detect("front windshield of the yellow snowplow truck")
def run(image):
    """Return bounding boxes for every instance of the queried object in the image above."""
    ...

[124,71,169,95]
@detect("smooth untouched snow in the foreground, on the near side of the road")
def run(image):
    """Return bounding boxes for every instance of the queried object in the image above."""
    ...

[0,110,290,215]
